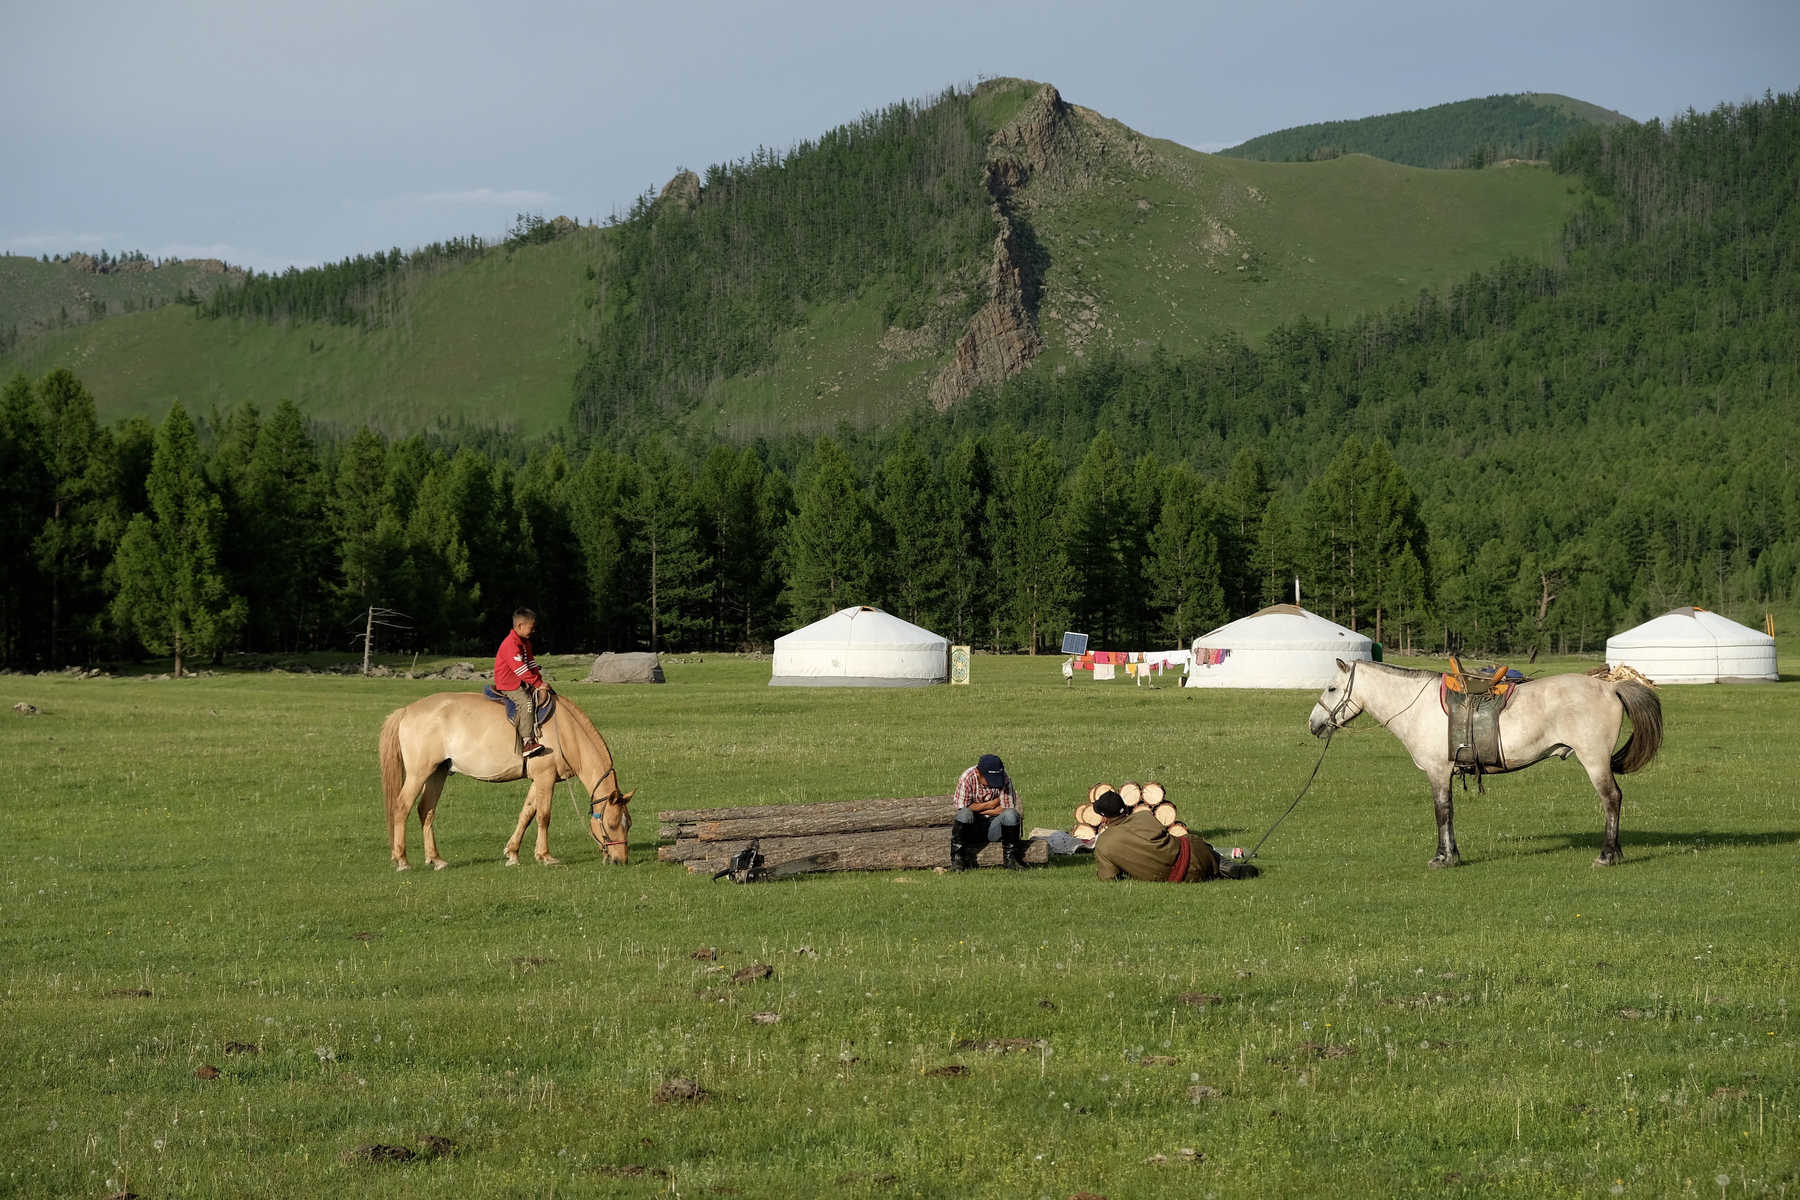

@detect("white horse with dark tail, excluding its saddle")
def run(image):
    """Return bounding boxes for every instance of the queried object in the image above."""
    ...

[1307,658,1663,867]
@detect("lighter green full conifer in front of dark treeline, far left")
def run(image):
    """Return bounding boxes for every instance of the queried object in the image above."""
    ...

[112,401,245,676]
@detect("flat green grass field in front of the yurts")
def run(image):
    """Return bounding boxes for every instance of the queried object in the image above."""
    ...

[0,658,1800,1198]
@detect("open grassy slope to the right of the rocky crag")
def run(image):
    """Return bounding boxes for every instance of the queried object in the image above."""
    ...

[1037,142,1573,356]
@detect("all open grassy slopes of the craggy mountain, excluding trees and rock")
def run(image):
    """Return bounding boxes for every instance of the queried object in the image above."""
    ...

[10,81,1575,439]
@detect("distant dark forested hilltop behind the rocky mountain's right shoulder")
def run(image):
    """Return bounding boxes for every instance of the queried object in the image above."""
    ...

[1220,92,1631,167]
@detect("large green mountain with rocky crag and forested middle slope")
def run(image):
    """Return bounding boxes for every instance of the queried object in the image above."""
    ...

[0,79,1579,441]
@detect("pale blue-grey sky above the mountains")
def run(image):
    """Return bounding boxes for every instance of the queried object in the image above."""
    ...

[0,0,1800,270]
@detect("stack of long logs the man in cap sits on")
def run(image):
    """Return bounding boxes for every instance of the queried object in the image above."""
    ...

[657,793,1051,874]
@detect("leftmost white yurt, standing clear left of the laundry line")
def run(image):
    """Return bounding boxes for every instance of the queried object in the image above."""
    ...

[769,604,950,687]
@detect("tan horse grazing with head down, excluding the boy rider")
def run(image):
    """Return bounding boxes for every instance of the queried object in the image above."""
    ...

[382,691,634,871]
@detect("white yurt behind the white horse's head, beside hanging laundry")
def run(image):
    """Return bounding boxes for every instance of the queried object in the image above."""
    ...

[1186,604,1373,687]
